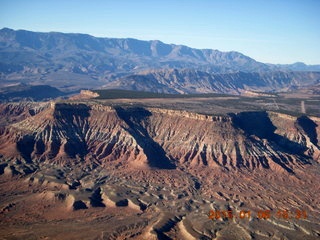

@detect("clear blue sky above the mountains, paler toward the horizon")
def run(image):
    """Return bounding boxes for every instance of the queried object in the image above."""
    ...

[0,0,320,64]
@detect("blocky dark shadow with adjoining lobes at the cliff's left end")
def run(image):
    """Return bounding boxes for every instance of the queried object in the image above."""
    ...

[16,103,91,163]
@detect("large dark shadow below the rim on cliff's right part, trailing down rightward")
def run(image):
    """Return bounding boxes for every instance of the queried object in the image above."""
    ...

[230,112,313,173]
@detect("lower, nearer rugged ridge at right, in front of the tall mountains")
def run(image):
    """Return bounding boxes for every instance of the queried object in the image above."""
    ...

[104,69,320,94]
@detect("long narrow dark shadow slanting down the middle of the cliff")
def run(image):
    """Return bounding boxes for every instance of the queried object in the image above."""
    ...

[115,107,175,169]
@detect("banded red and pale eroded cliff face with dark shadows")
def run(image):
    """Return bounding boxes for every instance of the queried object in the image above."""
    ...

[0,103,320,172]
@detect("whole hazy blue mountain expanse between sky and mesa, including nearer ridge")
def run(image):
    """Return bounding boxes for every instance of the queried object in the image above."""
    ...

[0,28,320,93]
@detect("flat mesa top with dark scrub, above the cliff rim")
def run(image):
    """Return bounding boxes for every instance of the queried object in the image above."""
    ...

[72,90,320,117]
